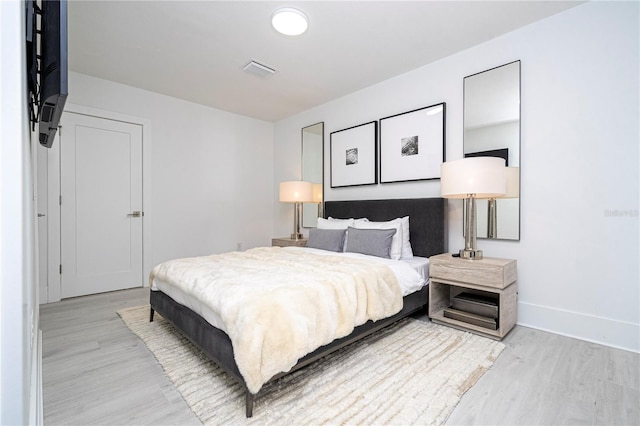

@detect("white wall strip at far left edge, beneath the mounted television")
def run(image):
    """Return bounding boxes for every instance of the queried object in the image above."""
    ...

[0,1,41,425]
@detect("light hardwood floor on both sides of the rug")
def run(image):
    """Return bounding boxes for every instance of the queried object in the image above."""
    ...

[40,289,640,425]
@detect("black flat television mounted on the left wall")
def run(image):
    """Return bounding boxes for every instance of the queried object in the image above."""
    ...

[27,0,69,148]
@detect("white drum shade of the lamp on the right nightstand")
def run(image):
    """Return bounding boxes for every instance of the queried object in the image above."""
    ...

[440,157,506,198]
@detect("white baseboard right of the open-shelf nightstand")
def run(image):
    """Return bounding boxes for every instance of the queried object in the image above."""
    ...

[518,302,640,353]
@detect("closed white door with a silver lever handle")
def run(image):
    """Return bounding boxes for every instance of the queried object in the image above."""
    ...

[60,112,143,298]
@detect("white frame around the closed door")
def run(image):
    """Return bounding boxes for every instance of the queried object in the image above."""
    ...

[47,104,153,303]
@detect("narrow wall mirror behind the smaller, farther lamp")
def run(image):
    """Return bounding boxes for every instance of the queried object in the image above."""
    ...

[302,122,324,228]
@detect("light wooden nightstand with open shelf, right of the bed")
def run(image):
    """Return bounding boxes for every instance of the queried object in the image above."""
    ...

[429,253,518,340]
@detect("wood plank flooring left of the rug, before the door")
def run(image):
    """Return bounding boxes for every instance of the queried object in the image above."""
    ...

[40,289,200,425]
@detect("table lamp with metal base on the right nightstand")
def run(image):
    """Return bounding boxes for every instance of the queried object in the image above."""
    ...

[440,157,506,260]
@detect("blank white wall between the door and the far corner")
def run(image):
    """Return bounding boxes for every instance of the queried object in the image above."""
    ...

[61,73,274,276]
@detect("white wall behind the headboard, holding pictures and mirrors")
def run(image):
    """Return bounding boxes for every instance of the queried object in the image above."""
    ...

[274,2,640,351]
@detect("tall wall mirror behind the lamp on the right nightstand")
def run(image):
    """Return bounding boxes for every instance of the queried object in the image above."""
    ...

[464,61,520,240]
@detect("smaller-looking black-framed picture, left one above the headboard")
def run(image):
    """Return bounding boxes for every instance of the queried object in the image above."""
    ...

[329,121,378,188]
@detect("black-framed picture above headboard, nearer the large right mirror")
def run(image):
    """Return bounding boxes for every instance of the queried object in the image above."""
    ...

[380,102,447,183]
